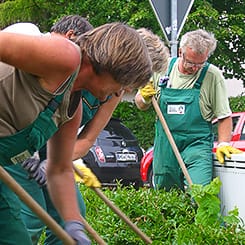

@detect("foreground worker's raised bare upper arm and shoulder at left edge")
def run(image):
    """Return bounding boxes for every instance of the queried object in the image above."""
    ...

[0,31,80,90]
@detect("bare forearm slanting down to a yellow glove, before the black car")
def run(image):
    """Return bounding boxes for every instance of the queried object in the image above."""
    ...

[73,96,122,160]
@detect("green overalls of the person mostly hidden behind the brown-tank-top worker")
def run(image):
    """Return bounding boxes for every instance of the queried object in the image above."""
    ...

[1,91,104,245]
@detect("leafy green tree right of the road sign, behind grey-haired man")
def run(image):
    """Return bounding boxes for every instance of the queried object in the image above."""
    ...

[182,0,245,82]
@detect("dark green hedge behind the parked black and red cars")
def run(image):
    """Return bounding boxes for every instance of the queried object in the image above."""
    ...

[113,95,245,150]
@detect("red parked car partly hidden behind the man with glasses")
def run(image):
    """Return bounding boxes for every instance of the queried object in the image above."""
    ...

[140,112,245,186]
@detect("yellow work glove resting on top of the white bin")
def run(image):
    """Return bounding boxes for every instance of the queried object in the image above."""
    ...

[216,142,243,164]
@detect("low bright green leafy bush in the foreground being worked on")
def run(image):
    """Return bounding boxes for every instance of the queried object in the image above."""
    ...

[80,180,245,245]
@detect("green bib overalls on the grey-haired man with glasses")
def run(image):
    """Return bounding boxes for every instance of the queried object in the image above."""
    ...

[153,58,213,190]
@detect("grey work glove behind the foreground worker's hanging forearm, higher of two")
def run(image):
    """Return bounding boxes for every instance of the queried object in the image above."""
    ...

[21,152,47,186]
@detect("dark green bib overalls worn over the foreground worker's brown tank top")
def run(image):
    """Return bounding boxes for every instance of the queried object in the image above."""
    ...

[0,73,77,245]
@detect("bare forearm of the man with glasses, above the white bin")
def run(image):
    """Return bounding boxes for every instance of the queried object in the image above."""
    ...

[218,117,232,143]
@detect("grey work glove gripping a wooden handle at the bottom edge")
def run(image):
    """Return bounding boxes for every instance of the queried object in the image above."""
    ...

[65,220,91,245]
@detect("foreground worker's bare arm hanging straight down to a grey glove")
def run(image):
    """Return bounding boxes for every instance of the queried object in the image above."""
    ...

[47,103,81,221]
